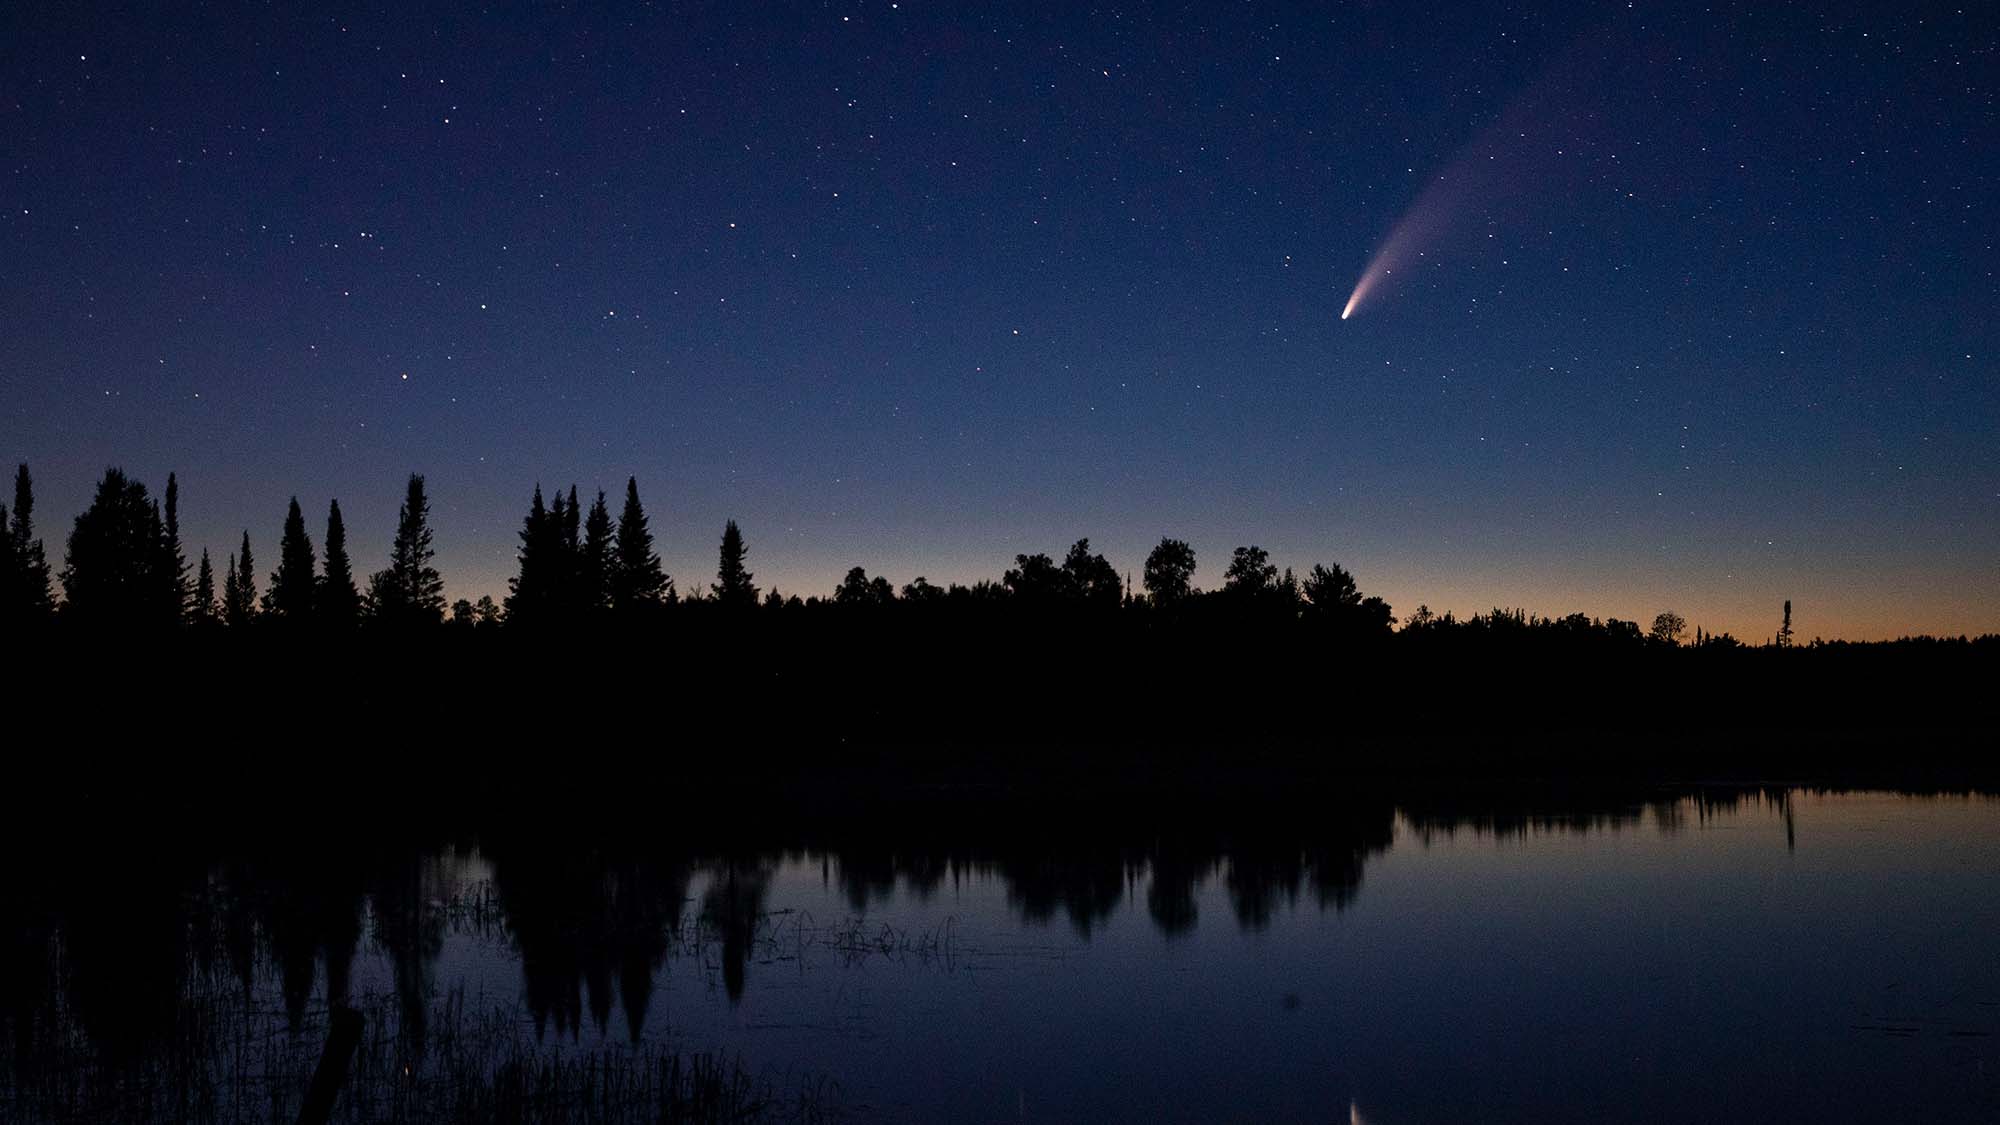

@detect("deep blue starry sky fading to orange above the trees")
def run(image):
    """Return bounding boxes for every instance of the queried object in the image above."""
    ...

[0,0,2000,641]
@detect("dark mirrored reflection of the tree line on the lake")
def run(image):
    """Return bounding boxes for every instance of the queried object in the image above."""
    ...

[0,789,1992,1119]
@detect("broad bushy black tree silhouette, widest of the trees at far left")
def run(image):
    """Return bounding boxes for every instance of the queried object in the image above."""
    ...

[59,468,176,629]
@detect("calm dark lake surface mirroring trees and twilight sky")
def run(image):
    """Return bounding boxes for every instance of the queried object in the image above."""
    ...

[0,789,2000,1123]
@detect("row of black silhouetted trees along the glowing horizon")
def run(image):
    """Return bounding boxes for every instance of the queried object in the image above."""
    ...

[0,464,1984,649]
